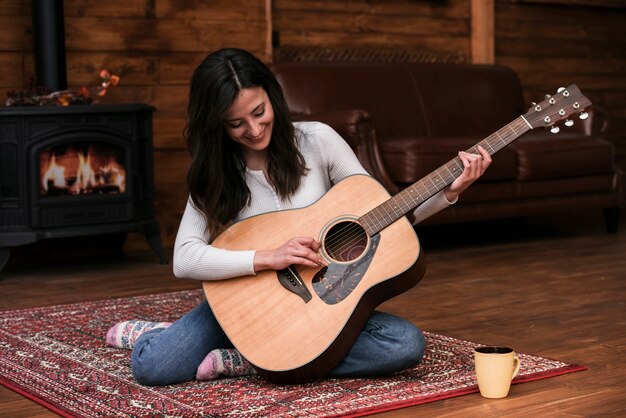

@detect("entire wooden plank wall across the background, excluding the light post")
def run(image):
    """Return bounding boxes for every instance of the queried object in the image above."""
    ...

[0,0,626,251]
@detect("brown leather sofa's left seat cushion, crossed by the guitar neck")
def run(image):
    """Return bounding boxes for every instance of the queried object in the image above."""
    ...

[379,137,518,185]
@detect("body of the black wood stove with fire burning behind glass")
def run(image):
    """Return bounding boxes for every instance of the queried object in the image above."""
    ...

[0,104,165,270]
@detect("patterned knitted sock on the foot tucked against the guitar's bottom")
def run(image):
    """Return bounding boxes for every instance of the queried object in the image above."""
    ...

[196,348,256,380]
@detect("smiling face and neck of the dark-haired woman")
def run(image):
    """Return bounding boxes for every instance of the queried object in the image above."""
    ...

[225,87,274,169]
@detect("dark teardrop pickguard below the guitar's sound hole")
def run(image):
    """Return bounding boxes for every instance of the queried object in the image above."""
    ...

[313,234,380,305]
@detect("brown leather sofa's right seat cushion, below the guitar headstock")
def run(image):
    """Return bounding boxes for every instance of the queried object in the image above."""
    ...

[510,131,614,180]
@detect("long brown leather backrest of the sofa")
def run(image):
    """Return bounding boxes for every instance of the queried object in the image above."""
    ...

[270,62,525,141]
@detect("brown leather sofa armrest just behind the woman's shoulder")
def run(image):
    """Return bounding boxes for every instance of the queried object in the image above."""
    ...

[292,109,398,194]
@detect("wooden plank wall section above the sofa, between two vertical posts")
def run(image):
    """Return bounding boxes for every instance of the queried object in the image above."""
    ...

[272,0,471,57]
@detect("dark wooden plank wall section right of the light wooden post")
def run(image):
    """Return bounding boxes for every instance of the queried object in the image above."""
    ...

[495,0,626,170]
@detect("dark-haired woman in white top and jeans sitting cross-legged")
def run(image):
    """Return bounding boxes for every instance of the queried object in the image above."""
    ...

[107,49,491,385]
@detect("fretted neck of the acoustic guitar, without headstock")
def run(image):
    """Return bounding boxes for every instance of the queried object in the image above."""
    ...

[359,116,532,236]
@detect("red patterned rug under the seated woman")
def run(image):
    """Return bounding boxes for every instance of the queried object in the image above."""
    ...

[0,290,585,417]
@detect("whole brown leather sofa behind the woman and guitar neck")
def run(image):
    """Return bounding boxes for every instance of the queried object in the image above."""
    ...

[271,63,625,232]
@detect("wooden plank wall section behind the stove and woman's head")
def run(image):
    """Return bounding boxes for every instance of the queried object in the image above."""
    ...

[0,0,268,248]
